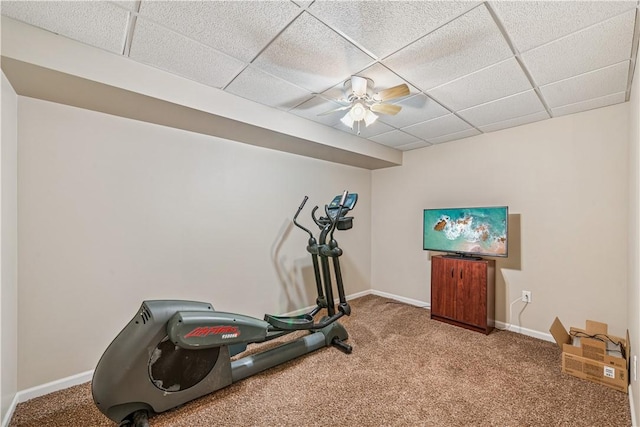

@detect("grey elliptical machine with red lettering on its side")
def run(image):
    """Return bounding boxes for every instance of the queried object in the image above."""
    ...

[91,191,358,427]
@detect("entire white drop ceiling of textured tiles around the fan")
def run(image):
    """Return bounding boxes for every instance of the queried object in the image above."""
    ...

[0,0,640,151]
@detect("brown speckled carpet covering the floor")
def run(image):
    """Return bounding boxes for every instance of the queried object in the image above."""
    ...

[10,296,631,427]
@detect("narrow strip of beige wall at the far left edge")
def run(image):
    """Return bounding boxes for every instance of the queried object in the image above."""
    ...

[0,73,18,421]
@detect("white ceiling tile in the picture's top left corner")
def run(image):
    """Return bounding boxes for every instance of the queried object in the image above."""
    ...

[1,0,129,54]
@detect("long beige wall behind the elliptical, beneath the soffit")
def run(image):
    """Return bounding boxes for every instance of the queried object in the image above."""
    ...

[18,97,371,389]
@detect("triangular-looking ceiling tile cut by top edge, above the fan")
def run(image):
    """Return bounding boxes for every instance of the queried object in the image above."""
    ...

[309,1,479,58]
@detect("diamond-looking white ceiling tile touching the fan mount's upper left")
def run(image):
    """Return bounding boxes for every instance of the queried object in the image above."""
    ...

[253,12,372,92]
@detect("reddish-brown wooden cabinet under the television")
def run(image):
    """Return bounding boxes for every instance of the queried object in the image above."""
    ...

[431,255,495,334]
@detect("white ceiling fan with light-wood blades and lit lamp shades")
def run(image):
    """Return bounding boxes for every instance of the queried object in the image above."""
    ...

[320,76,410,135]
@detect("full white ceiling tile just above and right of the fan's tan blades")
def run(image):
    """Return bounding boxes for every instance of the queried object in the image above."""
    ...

[383,5,513,91]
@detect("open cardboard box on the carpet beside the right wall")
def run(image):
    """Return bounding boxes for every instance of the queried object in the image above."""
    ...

[549,317,629,393]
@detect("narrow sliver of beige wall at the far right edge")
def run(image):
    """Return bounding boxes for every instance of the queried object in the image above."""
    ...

[627,52,640,423]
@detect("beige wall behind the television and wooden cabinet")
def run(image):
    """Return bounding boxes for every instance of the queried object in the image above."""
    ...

[371,104,629,334]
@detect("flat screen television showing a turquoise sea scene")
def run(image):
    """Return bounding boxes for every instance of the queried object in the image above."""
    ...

[422,206,509,258]
